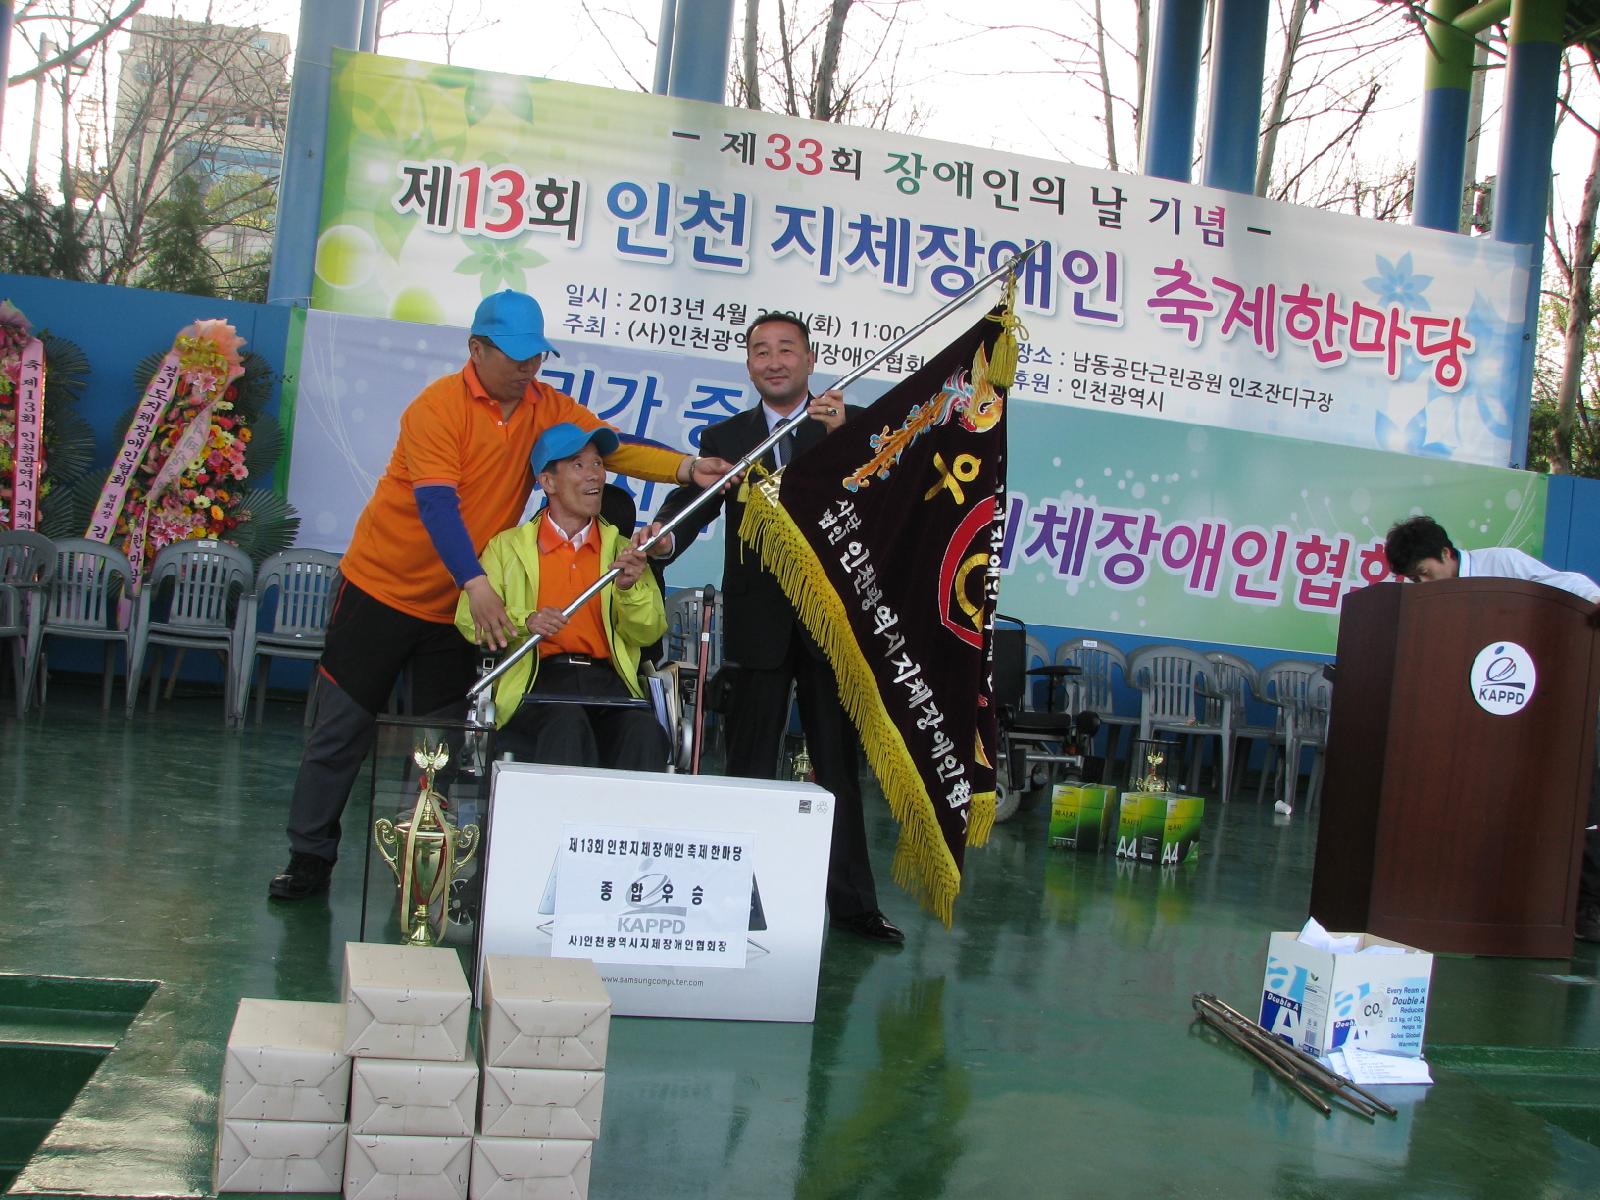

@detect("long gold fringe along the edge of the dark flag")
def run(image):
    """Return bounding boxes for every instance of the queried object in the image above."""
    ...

[739,474,972,928]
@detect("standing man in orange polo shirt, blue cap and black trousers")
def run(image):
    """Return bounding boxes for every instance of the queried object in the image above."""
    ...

[267,291,730,899]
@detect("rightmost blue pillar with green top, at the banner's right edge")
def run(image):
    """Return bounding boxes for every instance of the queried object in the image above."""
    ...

[1493,0,1566,467]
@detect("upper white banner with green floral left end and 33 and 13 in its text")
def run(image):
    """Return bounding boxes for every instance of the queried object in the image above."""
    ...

[312,51,1526,464]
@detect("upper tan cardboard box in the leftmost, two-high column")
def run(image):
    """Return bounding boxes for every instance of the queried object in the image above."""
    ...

[219,1000,350,1122]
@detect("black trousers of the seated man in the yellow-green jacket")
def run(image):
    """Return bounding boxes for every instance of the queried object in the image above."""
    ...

[494,661,667,771]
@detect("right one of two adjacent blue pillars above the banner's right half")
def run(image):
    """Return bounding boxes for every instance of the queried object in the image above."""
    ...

[1205,0,1270,192]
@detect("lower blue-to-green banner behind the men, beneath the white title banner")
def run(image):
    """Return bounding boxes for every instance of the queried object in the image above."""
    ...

[288,310,1547,654]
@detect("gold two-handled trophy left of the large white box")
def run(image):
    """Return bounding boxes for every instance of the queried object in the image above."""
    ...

[373,742,478,946]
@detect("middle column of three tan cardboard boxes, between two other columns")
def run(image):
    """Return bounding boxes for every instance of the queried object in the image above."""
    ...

[344,942,478,1200]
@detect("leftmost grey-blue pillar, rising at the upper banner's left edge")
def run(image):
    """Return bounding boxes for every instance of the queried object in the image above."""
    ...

[267,0,362,306]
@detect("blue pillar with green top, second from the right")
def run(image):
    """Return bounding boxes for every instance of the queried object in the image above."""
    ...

[1411,0,1474,234]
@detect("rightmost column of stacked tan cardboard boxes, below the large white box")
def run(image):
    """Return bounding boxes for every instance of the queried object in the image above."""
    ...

[472,954,611,1200]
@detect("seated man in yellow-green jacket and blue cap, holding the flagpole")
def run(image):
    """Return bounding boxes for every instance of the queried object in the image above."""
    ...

[456,422,667,771]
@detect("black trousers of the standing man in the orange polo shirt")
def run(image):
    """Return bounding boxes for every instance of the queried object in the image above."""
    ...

[288,581,477,862]
